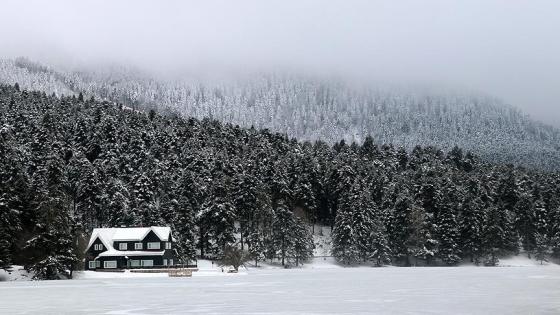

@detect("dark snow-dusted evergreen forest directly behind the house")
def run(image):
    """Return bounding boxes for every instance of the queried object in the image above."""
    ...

[0,86,560,278]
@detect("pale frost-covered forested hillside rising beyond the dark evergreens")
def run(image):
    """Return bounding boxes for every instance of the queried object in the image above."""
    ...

[0,58,560,170]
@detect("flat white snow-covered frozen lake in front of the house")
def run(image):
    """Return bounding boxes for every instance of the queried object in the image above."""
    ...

[0,266,560,314]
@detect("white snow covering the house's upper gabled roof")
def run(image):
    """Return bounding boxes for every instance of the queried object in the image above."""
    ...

[87,226,171,250]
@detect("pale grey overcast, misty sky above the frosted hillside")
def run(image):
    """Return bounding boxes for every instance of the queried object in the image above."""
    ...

[0,0,560,126]
